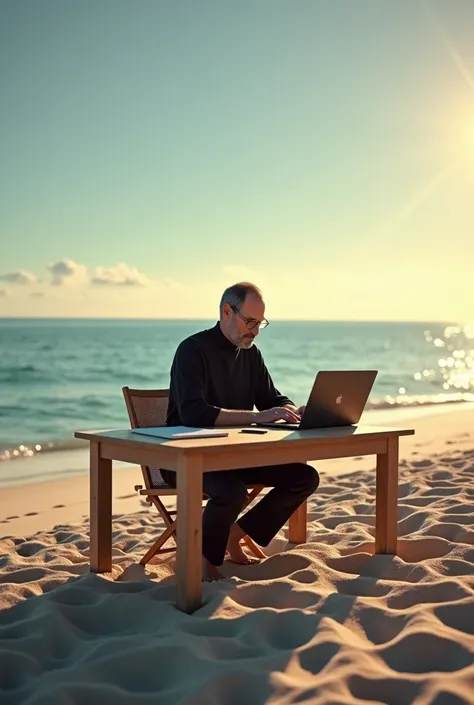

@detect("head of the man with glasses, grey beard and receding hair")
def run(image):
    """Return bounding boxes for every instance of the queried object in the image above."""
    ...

[219,282,268,348]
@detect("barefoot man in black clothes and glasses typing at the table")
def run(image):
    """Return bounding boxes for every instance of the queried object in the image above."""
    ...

[162,282,319,581]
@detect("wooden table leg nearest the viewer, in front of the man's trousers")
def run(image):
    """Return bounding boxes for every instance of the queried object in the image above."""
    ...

[176,456,202,612]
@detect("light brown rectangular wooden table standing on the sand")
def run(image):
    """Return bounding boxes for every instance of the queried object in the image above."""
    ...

[75,426,414,612]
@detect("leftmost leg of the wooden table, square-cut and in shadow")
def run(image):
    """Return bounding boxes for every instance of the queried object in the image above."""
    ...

[90,442,112,573]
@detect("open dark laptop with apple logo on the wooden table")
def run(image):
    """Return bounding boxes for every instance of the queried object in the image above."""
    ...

[256,370,378,431]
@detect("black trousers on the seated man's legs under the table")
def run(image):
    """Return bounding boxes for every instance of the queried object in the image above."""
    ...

[163,463,319,566]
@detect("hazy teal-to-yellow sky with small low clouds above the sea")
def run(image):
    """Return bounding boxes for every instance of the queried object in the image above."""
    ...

[0,0,474,323]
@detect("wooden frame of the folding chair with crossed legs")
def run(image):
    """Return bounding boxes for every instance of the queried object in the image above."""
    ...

[122,387,266,565]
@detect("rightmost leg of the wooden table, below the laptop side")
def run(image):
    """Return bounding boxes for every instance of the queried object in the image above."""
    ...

[375,437,399,555]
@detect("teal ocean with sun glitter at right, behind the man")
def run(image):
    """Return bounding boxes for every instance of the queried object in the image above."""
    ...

[0,319,474,464]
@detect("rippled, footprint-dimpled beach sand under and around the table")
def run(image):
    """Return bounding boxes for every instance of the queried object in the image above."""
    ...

[0,411,474,705]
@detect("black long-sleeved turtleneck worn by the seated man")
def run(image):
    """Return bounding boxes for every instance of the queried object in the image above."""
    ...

[167,323,293,427]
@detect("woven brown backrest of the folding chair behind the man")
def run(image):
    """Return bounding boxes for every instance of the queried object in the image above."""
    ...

[122,387,169,489]
